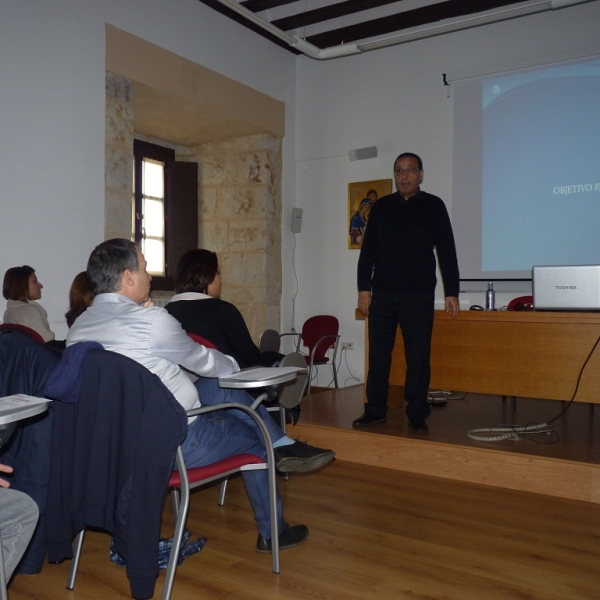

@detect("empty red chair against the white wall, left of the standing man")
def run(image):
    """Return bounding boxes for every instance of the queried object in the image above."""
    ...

[281,315,340,394]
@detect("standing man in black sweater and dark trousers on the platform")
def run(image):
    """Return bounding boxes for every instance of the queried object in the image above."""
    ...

[352,152,460,434]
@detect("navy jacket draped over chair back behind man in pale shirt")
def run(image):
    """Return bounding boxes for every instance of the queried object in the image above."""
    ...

[47,344,187,598]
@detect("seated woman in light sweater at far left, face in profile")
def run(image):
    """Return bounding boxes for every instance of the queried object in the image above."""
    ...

[2,265,54,342]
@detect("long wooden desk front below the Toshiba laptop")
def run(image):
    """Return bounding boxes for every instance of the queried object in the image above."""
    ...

[357,310,600,404]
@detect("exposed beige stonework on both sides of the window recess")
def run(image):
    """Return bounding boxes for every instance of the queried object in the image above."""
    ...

[105,73,282,341]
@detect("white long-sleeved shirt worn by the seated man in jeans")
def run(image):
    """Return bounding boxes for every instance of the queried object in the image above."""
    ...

[67,294,239,410]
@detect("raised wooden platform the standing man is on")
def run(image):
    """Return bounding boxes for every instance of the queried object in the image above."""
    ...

[288,385,600,504]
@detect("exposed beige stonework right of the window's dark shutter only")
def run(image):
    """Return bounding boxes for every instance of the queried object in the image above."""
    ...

[185,134,282,341]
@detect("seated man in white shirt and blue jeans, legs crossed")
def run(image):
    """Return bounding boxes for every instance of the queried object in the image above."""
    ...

[67,238,335,552]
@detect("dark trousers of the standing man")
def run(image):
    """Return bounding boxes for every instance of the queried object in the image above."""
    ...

[366,290,434,421]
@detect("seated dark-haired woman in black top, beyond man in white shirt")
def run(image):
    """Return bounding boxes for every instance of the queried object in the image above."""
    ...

[165,249,283,368]
